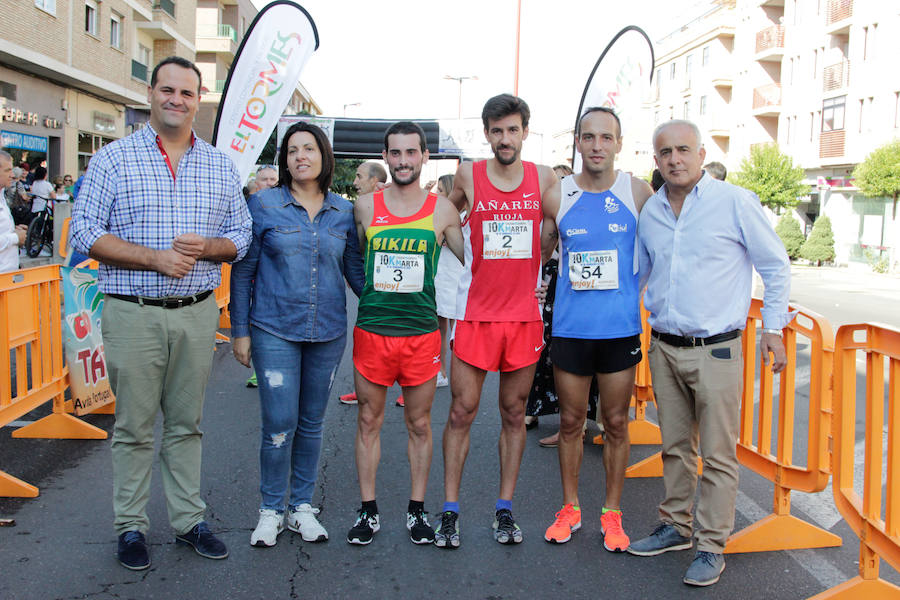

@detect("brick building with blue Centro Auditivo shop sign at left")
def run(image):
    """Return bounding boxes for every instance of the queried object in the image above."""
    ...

[0,0,196,176]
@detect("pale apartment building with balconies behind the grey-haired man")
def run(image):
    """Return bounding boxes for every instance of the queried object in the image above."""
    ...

[645,0,900,264]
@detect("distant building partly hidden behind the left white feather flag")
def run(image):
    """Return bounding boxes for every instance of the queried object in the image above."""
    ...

[194,0,322,141]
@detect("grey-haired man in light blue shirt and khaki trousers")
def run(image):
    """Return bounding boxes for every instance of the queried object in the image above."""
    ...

[628,121,793,586]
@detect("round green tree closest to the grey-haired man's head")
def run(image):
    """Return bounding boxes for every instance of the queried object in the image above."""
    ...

[728,144,809,213]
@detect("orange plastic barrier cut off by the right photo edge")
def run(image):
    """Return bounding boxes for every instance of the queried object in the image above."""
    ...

[815,323,900,600]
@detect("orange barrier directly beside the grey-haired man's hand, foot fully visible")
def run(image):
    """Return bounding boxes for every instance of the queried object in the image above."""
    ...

[725,298,841,553]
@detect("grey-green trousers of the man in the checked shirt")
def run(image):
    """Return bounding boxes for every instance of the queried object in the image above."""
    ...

[101,296,219,534]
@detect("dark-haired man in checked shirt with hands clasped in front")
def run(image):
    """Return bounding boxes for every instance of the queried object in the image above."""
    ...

[71,57,251,570]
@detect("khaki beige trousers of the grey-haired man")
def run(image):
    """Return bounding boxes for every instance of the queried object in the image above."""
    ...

[649,337,744,554]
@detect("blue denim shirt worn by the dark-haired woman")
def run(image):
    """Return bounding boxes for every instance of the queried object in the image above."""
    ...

[230,186,365,342]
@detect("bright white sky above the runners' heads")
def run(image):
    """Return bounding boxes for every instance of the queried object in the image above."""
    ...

[253,0,710,159]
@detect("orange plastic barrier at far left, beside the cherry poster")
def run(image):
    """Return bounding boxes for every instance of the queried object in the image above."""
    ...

[0,265,106,498]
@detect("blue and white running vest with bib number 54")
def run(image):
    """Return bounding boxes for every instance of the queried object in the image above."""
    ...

[553,171,642,340]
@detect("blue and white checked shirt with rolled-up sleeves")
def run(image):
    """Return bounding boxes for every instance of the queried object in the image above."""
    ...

[71,124,251,298]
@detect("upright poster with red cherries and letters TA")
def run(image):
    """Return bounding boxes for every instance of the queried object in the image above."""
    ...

[60,267,115,415]
